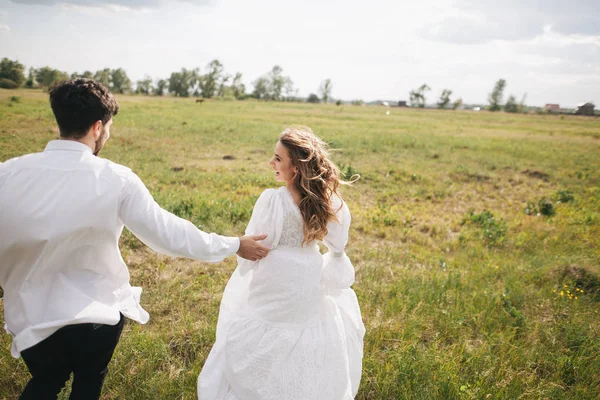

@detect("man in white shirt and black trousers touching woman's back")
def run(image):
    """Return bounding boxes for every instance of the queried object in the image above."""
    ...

[0,79,268,400]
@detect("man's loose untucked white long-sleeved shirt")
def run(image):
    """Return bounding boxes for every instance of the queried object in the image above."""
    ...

[0,140,239,358]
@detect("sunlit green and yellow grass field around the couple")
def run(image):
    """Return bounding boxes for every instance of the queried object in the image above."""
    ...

[0,90,600,400]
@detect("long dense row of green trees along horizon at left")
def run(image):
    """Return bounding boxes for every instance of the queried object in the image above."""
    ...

[0,58,333,103]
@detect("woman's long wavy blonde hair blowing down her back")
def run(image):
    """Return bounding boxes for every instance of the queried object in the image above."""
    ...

[279,127,356,244]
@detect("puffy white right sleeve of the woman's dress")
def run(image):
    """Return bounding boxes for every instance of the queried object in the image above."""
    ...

[321,197,354,290]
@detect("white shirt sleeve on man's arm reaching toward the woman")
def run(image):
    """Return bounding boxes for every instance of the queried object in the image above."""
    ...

[119,172,240,262]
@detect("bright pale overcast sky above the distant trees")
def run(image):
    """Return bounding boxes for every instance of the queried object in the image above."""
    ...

[0,0,600,107]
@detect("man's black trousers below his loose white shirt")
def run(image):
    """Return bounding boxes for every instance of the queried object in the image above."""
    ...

[20,314,125,400]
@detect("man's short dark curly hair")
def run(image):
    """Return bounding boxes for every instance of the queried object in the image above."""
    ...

[50,79,119,139]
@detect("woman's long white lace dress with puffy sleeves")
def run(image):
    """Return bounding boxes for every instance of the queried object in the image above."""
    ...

[198,187,365,400]
